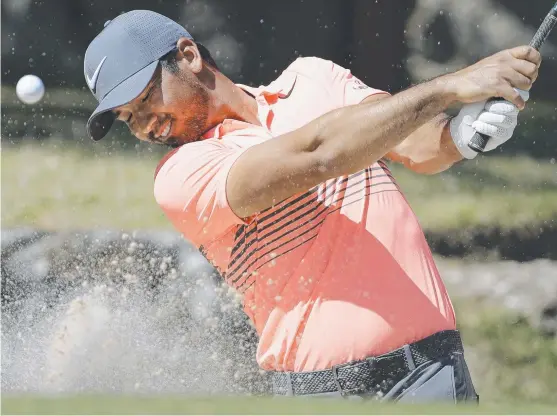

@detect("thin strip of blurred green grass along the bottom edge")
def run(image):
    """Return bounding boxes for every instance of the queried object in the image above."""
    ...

[2,396,557,415]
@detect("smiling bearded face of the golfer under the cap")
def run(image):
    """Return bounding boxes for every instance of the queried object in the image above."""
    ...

[114,54,209,146]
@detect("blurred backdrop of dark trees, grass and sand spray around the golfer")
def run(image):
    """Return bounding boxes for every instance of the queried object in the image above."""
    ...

[1,0,557,410]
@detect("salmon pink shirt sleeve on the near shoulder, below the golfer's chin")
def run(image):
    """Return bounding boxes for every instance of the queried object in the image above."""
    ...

[154,139,246,246]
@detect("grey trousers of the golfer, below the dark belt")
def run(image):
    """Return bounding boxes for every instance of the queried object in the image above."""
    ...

[292,353,479,404]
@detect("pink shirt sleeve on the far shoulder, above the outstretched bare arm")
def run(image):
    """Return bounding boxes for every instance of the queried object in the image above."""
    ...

[288,57,388,106]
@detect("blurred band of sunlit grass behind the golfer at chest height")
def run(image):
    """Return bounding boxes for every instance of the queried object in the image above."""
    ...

[2,141,557,231]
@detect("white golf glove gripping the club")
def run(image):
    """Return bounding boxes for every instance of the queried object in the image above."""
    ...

[450,90,530,159]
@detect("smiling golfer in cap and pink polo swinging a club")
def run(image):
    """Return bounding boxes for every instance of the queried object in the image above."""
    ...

[85,10,541,403]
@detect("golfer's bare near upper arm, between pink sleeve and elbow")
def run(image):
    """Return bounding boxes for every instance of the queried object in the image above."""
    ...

[226,124,326,218]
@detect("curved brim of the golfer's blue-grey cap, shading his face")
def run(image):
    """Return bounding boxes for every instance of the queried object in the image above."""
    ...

[87,61,159,141]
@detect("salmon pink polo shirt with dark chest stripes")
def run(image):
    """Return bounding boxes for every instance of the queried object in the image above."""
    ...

[154,58,455,371]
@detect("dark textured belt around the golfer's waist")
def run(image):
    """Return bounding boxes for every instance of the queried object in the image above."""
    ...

[272,331,463,396]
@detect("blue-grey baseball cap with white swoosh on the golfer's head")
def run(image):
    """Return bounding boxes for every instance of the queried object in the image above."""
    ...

[84,10,193,140]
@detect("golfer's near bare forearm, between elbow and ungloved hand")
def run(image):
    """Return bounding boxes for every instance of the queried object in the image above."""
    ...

[314,78,453,176]
